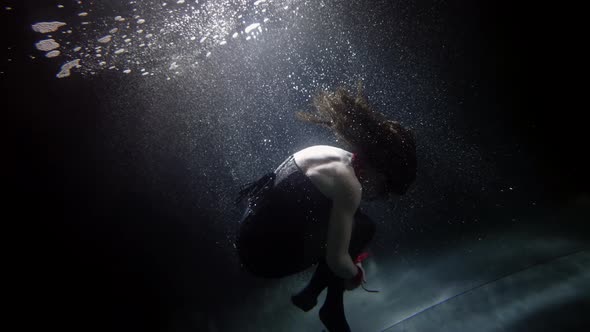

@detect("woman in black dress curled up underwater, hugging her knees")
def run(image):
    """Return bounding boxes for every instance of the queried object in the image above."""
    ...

[236,85,416,332]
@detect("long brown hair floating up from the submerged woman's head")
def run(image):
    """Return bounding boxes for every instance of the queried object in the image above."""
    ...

[296,83,416,195]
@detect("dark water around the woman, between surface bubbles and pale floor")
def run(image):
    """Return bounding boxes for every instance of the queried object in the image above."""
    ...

[0,1,590,331]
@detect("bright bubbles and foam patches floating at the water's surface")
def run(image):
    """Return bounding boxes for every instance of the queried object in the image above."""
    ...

[31,0,295,77]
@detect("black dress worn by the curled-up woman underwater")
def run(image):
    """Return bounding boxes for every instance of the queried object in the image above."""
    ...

[236,155,375,278]
